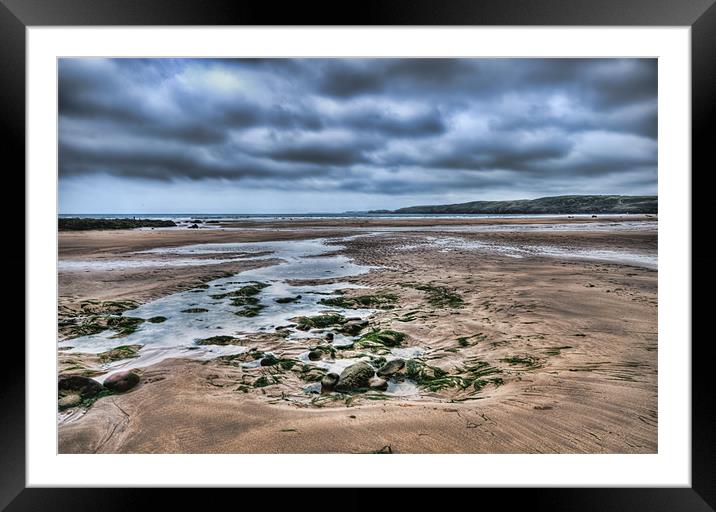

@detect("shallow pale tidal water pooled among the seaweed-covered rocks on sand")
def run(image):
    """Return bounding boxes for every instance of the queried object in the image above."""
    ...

[59,238,423,396]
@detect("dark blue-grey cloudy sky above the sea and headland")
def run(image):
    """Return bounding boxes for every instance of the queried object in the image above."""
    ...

[58,59,657,213]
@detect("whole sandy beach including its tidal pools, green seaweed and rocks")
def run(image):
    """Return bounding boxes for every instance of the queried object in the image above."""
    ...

[58,215,658,453]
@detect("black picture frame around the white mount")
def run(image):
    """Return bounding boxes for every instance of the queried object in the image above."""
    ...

[0,0,716,511]
